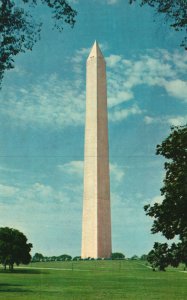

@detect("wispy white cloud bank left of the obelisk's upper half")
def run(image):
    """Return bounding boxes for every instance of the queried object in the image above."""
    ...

[1,74,85,128]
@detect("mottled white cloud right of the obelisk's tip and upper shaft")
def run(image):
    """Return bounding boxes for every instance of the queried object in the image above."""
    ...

[106,49,187,106]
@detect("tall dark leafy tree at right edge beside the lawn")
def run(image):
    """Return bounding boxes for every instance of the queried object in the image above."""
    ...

[144,125,187,267]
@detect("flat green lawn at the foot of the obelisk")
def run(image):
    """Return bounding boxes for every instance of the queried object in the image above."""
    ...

[0,261,187,300]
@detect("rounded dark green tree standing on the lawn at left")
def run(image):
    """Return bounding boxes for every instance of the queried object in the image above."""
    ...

[0,227,32,270]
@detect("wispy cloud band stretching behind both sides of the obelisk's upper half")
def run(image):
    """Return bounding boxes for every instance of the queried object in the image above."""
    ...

[0,46,187,128]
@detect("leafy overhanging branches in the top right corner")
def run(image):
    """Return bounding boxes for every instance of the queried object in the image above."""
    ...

[129,0,187,50]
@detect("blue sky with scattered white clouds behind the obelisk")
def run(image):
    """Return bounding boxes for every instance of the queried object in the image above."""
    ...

[0,0,187,256]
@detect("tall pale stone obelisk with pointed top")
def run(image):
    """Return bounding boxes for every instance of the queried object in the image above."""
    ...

[81,42,111,258]
